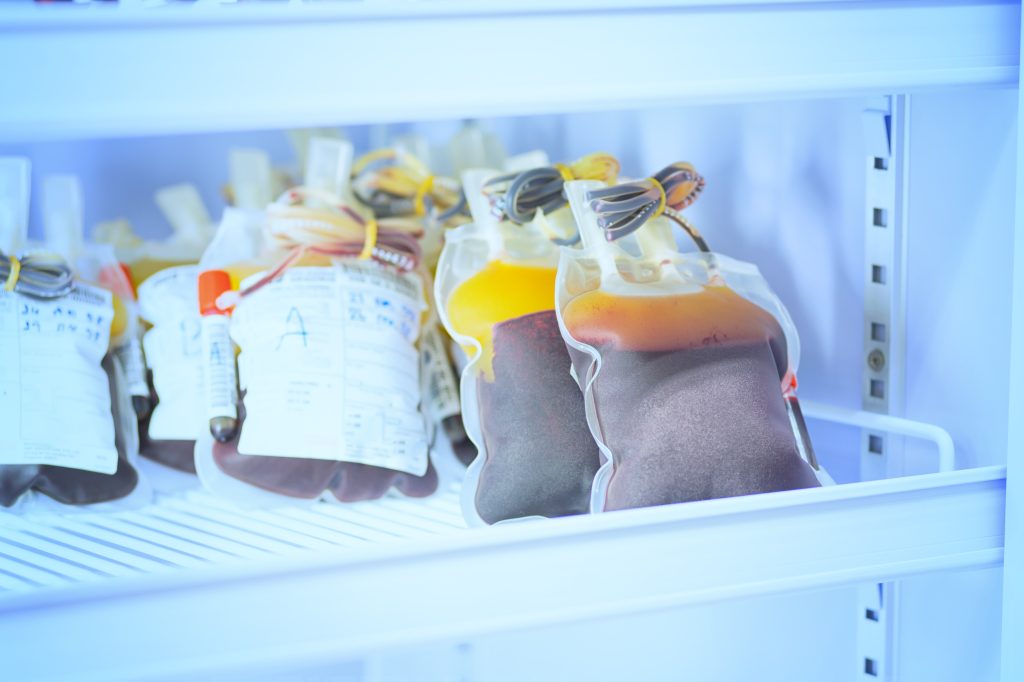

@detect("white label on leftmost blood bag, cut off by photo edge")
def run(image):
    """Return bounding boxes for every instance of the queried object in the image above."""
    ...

[0,284,118,474]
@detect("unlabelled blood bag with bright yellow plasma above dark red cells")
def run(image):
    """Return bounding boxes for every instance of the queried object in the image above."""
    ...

[435,166,599,523]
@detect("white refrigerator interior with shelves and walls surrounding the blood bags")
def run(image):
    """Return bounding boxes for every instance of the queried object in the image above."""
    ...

[0,0,1024,682]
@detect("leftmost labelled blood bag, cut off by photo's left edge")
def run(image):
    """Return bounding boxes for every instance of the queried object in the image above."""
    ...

[0,159,138,507]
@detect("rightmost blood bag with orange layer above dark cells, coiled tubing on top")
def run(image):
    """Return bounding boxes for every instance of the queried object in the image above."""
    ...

[557,166,818,511]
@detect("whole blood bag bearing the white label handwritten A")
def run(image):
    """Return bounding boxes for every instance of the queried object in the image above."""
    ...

[196,138,438,503]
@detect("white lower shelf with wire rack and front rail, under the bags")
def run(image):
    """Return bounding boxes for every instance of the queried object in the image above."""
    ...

[0,467,1006,680]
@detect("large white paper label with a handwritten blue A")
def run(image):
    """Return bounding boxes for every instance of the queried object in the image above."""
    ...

[231,263,427,476]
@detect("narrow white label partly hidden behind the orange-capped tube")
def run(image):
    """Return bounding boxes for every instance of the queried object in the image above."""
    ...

[138,265,205,440]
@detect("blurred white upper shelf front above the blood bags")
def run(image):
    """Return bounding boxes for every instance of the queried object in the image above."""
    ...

[0,0,1020,141]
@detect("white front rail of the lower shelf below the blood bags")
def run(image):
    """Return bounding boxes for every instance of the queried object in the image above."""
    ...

[0,467,1006,681]
